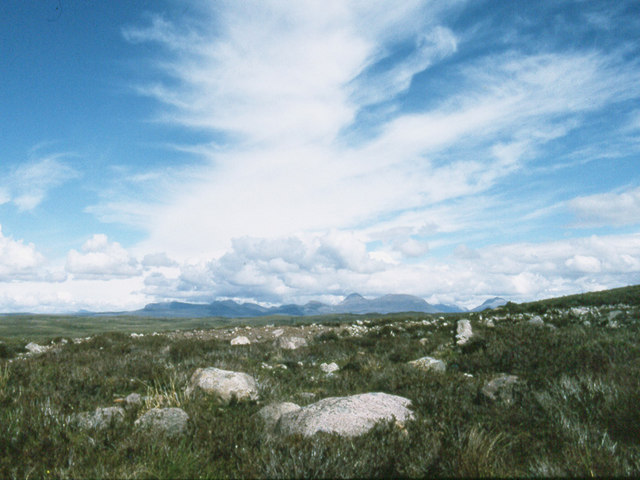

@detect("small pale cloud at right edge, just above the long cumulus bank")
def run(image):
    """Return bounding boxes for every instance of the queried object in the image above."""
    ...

[568,187,640,226]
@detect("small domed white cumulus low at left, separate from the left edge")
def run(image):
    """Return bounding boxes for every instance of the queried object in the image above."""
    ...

[66,234,141,279]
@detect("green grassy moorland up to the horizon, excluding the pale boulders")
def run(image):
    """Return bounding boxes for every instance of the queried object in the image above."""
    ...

[0,287,640,478]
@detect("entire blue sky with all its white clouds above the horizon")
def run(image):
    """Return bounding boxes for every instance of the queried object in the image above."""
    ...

[0,0,640,313]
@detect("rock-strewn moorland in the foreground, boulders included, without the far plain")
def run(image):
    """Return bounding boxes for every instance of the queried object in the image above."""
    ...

[0,294,640,478]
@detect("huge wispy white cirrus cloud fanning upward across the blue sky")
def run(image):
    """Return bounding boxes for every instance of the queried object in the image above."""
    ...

[79,1,640,306]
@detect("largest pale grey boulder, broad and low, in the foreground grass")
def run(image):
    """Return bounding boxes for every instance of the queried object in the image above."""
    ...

[276,392,413,437]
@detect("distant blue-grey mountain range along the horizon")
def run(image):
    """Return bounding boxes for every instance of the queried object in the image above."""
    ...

[128,293,507,318]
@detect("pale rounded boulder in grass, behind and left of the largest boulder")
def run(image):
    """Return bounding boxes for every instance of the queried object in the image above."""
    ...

[185,367,258,405]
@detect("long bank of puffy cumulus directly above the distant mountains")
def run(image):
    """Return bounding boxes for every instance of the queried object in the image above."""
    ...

[144,233,640,307]
